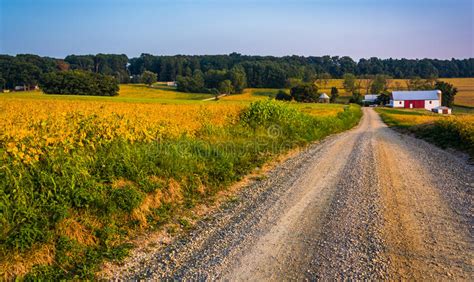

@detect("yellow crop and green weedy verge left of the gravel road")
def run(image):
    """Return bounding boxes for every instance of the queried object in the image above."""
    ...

[0,95,361,280]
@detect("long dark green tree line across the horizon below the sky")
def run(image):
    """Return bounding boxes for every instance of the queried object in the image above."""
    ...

[0,53,474,93]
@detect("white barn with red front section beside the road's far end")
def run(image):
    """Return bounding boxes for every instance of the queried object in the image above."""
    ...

[390,90,441,111]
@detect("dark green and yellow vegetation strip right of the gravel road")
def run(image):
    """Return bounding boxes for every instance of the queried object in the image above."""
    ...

[376,108,474,159]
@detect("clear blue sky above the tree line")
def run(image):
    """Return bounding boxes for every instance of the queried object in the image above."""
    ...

[0,0,474,59]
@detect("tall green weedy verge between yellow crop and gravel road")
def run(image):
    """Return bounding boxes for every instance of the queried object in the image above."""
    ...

[0,101,362,280]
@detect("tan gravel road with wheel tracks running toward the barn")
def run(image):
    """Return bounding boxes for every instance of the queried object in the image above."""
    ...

[116,108,474,280]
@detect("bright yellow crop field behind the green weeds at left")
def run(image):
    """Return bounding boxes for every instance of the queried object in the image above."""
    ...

[0,99,243,163]
